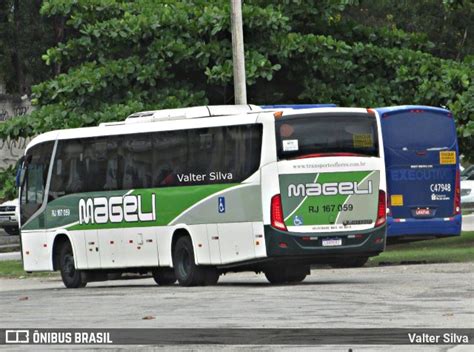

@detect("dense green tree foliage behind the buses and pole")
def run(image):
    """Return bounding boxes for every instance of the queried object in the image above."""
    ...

[0,0,474,165]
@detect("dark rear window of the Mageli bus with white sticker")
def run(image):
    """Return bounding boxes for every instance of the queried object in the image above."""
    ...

[276,113,379,160]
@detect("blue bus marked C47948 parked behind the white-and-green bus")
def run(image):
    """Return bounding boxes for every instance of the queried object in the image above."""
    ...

[376,105,461,242]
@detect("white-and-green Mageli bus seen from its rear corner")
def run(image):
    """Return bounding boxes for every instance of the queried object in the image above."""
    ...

[19,106,386,288]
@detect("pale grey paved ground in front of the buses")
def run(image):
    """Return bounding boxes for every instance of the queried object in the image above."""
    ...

[0,263,474,351]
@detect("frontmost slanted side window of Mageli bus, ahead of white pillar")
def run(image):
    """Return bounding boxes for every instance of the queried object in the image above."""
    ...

[20,142,54,224]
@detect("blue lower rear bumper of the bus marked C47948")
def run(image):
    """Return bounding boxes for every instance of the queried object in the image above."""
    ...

[387,215,462,238]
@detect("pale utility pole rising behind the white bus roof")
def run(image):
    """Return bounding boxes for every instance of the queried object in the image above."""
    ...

[230,0,247,105]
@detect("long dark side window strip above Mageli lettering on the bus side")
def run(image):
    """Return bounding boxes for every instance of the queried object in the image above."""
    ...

[49,125,262,195]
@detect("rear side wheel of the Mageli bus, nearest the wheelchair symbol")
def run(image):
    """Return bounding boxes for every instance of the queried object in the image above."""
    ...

[173,236,205,286]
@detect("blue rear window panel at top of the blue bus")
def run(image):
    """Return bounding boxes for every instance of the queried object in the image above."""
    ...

[383,112,456,150]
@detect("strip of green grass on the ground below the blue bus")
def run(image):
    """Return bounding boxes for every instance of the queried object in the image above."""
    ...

[369,232,474,265]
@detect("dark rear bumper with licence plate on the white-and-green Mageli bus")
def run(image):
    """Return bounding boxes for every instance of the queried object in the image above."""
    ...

[265,225,386,264]
